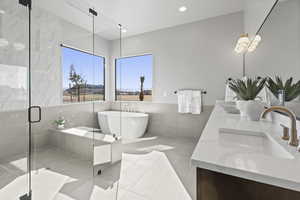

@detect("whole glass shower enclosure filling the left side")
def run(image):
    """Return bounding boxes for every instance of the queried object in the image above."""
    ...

[0,0,122,200]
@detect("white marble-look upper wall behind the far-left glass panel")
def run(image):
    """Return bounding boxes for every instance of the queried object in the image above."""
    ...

[0,0,29,111]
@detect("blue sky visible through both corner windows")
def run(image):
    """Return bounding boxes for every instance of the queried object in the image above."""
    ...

[62,47,153,91]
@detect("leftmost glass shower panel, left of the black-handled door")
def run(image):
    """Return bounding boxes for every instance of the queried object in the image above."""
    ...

[0,0,30,200]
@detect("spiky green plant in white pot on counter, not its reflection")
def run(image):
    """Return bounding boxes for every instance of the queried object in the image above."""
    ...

[229,78,266,121]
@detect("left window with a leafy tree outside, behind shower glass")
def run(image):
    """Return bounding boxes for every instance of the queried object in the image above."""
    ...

[62,46,105,103]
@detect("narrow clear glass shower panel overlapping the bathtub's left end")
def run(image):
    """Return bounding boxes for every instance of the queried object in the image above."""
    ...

[91,12,122,200]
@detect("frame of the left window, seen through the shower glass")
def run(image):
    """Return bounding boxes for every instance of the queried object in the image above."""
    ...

[60,43,106,105]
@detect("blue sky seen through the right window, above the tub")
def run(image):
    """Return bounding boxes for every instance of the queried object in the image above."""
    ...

[116,54,153,90]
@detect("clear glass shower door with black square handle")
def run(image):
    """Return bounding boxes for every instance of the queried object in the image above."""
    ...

[31,0,94,200]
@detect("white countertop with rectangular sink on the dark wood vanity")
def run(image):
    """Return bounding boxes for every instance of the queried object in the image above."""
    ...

[191,105,300,191]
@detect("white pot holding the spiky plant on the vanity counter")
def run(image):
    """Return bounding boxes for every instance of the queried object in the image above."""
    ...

[245,100,265,121]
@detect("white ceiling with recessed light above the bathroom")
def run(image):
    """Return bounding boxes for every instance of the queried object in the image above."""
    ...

[34,0,243,39]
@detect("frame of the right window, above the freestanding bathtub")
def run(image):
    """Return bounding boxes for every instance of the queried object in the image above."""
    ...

[114,53,154,103]
